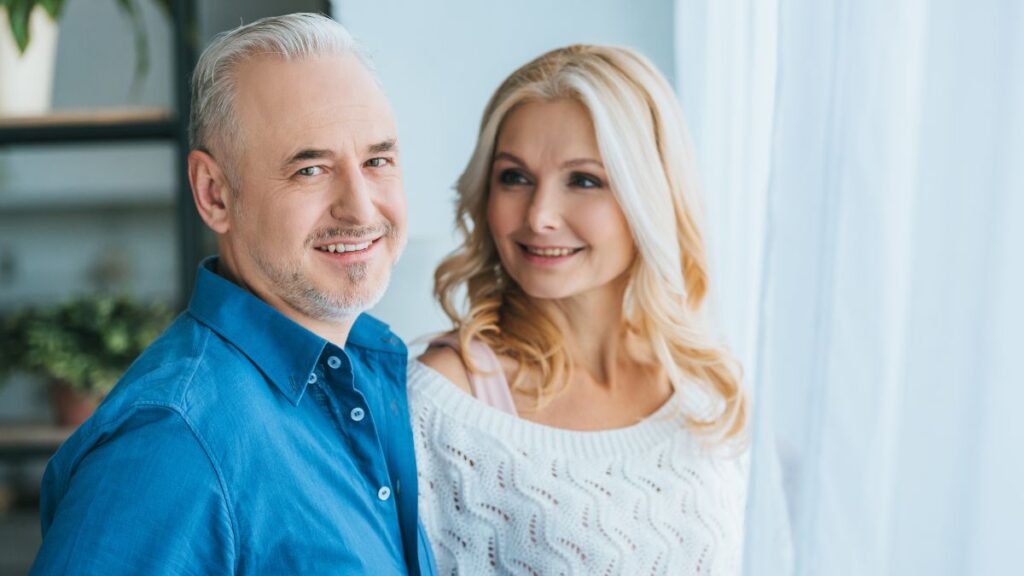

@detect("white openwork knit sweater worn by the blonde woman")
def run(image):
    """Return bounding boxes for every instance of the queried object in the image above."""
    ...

[409,362,749,576]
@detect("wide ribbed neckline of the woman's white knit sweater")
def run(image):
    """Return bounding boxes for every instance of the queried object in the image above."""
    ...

[409,360,689,457]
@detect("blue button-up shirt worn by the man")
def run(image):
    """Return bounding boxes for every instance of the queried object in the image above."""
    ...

[32,258,434,576]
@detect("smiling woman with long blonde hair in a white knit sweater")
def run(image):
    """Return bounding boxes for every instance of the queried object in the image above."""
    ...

[410,45,746,575]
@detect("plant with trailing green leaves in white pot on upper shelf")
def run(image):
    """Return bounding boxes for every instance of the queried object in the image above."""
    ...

[0,0,173,115]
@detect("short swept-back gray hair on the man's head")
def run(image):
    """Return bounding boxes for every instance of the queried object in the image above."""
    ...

[188,13,376,177]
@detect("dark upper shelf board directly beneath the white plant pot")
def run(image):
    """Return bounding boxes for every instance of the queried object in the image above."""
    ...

[0,109,179,146]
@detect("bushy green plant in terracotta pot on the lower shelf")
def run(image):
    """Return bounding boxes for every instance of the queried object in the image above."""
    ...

[0,294,172,426]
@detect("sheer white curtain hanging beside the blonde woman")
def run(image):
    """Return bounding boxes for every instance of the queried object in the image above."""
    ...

[676,0,1024,575]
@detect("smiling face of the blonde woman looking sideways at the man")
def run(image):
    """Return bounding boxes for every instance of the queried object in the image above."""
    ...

[487,99,636,299]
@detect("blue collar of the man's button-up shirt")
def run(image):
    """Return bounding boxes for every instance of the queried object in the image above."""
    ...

[188,256,406,405]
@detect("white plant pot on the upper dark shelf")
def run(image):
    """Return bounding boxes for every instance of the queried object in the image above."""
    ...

[0,5,57,116]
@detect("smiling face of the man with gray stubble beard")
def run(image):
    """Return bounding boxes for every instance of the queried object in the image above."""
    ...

[221,50,406,321]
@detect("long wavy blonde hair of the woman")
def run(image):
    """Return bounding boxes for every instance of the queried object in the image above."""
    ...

[434,45,746,440]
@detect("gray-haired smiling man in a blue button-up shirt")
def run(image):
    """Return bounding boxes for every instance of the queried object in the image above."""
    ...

[33,14,434,576]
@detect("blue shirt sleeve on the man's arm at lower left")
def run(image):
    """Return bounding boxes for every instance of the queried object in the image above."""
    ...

[31,407,236,576]
